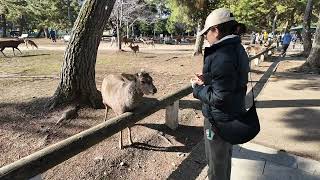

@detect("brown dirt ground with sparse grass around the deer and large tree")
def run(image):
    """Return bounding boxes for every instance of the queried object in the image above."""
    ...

[0,40,296,180]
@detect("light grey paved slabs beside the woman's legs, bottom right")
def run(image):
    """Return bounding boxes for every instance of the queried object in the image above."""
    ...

[196,143,320,180]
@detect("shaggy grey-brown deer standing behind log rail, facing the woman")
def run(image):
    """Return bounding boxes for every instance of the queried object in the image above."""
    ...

[101,71,157,149]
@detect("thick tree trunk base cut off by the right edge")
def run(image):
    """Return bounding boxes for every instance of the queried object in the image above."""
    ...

[306,14,320,68]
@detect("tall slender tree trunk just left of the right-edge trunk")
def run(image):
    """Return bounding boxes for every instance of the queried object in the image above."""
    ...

[302,0,313,57]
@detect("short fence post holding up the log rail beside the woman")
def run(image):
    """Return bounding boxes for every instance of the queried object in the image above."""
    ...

[165,100,179,130]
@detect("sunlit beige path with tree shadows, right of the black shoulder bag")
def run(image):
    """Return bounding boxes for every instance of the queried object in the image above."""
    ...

[253,58,320,161]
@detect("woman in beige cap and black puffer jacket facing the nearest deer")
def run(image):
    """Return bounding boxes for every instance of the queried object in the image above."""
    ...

[191,8,249,180]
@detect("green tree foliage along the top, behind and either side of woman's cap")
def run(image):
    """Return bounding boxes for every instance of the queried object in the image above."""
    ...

[162,0,320,31]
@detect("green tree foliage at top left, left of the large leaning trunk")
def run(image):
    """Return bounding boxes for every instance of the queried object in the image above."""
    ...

[0,0,80,29]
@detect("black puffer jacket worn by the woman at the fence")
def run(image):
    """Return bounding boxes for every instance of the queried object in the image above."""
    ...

[193,36,249,123]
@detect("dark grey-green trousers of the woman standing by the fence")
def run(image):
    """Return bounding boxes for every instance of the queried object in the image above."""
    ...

[204,118,232,180]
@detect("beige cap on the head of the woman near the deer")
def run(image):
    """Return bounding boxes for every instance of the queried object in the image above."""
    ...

[198,8,235,36]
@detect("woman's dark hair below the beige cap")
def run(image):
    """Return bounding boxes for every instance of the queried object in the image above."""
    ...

[215,20,247,39]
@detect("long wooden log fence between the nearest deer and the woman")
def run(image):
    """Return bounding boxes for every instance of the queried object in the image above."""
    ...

[0,47,275,180]
